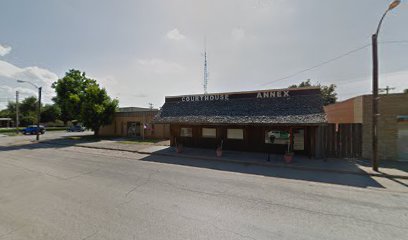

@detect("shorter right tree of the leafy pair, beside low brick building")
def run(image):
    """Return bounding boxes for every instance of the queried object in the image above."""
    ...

[81,83,118,136]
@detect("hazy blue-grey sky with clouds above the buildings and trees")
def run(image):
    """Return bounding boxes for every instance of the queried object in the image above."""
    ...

[0,0,408,109]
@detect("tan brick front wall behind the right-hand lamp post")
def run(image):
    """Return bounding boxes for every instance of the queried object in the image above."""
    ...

[363,94,408,160]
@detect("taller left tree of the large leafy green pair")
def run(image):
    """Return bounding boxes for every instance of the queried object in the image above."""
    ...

[52,69,96,125]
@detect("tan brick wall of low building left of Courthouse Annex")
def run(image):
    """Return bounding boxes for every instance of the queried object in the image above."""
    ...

[100,112,170,139]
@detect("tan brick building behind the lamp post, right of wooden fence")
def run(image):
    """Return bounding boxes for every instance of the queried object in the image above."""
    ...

[325,93,408,161]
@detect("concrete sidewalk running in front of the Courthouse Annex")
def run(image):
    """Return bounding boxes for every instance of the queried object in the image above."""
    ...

[37,139,408,179]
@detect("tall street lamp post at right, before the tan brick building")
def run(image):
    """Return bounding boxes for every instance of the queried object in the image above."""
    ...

[371,0,401,172]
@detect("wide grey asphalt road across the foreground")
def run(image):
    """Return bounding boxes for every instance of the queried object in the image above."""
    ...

[0,135,408,240]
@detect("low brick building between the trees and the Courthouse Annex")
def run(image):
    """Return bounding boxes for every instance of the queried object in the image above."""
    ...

[99,107,170,139]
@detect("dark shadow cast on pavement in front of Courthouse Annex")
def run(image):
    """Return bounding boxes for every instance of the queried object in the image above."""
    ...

[142,149,384,188]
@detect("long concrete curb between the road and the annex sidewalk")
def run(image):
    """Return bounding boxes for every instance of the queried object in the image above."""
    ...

[39,141,408,179]
